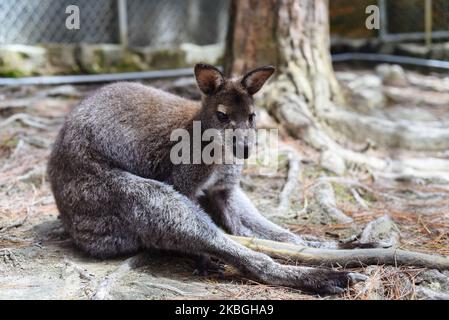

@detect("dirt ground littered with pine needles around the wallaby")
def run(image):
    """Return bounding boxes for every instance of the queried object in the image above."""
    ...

[0,70,449,299]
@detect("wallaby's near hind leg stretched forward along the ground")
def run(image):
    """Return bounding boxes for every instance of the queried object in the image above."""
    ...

[117,174,365,293]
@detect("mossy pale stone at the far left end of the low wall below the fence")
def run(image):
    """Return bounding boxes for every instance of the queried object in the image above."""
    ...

[0,44,46,77]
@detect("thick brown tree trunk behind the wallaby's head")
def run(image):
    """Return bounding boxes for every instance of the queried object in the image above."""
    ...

[225,0,343,144]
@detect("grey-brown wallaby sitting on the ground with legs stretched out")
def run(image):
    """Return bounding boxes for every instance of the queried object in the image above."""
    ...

[48,64,366,293]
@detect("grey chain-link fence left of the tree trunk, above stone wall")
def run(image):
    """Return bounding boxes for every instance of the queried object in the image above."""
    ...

[0,0,229,46]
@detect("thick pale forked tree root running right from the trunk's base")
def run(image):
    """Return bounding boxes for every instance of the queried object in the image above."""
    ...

[261,77,449,184]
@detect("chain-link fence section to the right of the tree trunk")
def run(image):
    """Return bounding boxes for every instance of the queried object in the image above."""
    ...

[329,0,449,42]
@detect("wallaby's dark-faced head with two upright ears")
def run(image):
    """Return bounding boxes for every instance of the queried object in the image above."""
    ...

[195,64,275,159]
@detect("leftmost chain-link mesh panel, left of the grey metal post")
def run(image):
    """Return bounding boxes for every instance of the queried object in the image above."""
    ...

[0,0,118,44]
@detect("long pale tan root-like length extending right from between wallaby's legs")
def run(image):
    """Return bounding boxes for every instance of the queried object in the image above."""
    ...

[229,236,449,270]
